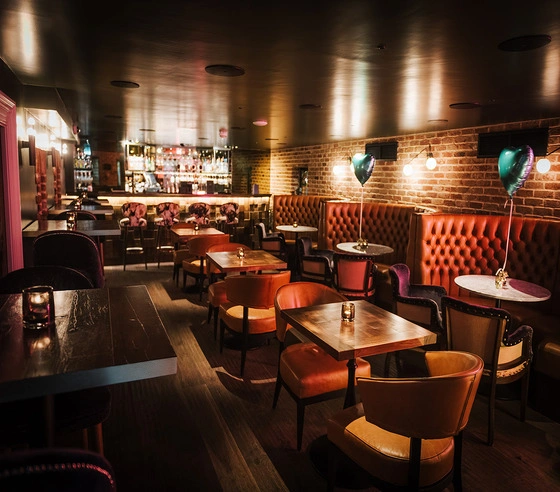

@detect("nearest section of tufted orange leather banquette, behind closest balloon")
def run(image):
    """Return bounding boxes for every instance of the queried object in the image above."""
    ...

[406,214,560,418]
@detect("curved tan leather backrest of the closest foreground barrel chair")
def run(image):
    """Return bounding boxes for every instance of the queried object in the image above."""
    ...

[357,351,484,439]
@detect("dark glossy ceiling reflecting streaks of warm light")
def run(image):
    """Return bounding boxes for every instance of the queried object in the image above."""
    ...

[0,0,560,149]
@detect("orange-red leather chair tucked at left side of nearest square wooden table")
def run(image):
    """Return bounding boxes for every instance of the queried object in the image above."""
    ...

[272,282,371,451]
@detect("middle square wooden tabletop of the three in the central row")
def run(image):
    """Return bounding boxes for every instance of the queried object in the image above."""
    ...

[206,249,288,273]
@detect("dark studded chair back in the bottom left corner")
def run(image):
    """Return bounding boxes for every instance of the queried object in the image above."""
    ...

[0,448,117,492]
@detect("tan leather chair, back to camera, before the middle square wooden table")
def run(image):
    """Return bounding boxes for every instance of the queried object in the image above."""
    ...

[219,270,291,377]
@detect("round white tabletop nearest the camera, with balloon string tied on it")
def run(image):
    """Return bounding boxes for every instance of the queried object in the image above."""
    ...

[455,275,551,307]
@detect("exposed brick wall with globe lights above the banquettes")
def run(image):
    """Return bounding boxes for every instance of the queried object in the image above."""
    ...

[270,118,560,219]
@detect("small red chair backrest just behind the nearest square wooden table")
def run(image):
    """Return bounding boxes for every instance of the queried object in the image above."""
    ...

[333,253,377,299]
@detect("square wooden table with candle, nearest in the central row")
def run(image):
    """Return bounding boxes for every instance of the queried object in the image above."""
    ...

[280,301,437,408]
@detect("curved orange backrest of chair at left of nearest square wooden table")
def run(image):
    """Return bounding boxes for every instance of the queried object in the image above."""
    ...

[274,282,346,342]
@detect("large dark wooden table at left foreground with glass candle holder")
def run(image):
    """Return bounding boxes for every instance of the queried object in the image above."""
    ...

[0,285,177,442]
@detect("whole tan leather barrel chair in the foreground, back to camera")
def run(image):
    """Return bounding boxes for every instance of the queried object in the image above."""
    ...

[327,351,484,490]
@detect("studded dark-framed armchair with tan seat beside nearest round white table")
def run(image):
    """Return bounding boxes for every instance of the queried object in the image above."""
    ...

[441,296,533,446]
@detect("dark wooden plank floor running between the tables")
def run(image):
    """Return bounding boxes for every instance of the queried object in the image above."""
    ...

[93,263,560,492]
